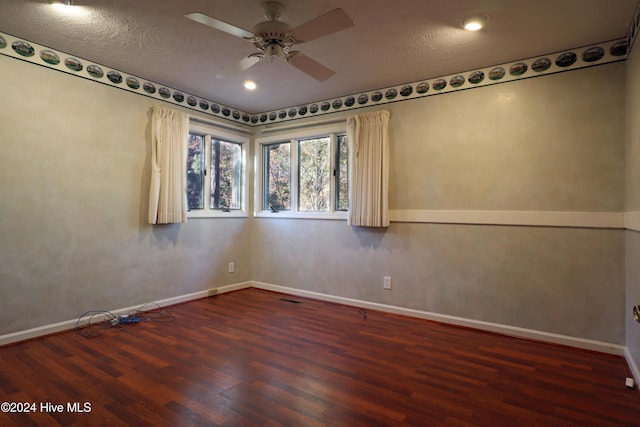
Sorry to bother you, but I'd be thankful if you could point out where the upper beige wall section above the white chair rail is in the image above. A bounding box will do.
[389,63,624,212]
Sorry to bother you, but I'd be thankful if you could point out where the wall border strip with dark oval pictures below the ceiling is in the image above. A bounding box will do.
[0,30,640,126]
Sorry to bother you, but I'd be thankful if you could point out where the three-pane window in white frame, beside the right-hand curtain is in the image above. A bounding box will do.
[256,123,349,218]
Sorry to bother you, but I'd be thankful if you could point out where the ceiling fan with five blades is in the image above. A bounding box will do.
[185,1,353,81]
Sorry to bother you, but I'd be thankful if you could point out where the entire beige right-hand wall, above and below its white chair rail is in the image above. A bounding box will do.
[252,63,625,344]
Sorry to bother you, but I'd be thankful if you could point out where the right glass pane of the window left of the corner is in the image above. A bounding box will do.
[210,139,242,210]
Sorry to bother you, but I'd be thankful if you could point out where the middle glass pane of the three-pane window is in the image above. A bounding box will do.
[298,137,331,211]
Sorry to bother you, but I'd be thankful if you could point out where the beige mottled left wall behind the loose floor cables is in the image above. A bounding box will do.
[0,56,251,334]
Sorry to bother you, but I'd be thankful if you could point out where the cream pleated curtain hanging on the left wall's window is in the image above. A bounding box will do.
[149,107,189,224]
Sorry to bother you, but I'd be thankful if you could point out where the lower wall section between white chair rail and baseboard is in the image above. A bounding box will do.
[253,219,624,344]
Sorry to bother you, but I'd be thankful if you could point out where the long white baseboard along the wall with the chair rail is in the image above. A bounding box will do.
[252,281,628,356]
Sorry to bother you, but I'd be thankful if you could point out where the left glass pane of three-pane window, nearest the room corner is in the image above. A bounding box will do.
[262,142,291,210]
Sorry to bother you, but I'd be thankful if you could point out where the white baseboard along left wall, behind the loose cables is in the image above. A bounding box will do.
[0,282,252,346]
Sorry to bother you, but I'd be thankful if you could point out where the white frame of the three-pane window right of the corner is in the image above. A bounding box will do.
[254,122,348,221]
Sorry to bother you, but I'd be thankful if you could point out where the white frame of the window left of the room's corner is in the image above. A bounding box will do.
[187,121,250,219]
